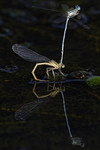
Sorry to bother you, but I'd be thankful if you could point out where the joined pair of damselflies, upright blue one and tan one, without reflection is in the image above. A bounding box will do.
[12,4,89,81]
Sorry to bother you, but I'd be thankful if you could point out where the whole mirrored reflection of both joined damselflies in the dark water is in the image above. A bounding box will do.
[15,82,85,148]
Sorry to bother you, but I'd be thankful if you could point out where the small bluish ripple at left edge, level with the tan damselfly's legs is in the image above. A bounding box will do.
[0,65,18,73]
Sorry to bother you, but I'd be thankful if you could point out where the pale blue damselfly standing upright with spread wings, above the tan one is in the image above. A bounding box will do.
[33,4,89,64]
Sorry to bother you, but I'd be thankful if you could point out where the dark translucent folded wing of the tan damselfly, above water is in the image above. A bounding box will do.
[12,44,50,62]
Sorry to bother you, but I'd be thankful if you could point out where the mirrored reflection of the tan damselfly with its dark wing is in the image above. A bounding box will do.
[15,82,65,120]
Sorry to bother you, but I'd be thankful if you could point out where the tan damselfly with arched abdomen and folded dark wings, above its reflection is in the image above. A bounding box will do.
[12,44,65,81]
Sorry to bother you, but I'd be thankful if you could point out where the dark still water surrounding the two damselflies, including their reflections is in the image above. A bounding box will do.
[0,0,100,150]
